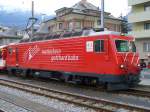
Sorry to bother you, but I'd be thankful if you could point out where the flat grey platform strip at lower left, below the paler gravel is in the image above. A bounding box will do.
[0,91,62,112]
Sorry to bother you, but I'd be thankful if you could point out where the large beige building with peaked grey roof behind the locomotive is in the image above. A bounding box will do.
[39,0,122,33]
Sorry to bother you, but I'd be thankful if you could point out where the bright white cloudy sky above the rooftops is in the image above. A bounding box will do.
[0,0,130,17]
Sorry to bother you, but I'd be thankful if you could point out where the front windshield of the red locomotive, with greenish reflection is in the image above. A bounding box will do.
[115,40,136,52]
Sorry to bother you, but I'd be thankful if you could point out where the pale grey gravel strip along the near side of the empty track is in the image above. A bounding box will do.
[0,85,95,112]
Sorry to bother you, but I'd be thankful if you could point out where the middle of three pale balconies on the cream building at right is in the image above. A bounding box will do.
[128,11,150,23]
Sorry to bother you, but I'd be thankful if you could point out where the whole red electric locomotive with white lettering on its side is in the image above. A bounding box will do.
[6,30,140,89]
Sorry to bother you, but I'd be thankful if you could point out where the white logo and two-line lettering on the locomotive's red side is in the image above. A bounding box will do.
[24,45,79,62]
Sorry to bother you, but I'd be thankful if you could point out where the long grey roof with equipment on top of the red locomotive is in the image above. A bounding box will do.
[20,29,131,43]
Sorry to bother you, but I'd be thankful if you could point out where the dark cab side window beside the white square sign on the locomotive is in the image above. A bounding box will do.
[94,40,104,52]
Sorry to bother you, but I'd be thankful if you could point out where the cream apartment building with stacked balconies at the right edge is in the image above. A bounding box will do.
[128,0,150,60]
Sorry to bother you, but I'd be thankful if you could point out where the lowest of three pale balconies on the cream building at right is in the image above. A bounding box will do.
[129,30,150,39]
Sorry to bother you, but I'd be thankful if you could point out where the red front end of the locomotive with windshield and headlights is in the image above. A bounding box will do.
[114,36,140,86]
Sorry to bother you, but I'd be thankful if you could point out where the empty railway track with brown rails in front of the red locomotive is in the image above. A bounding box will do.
[0,79,150,112]
